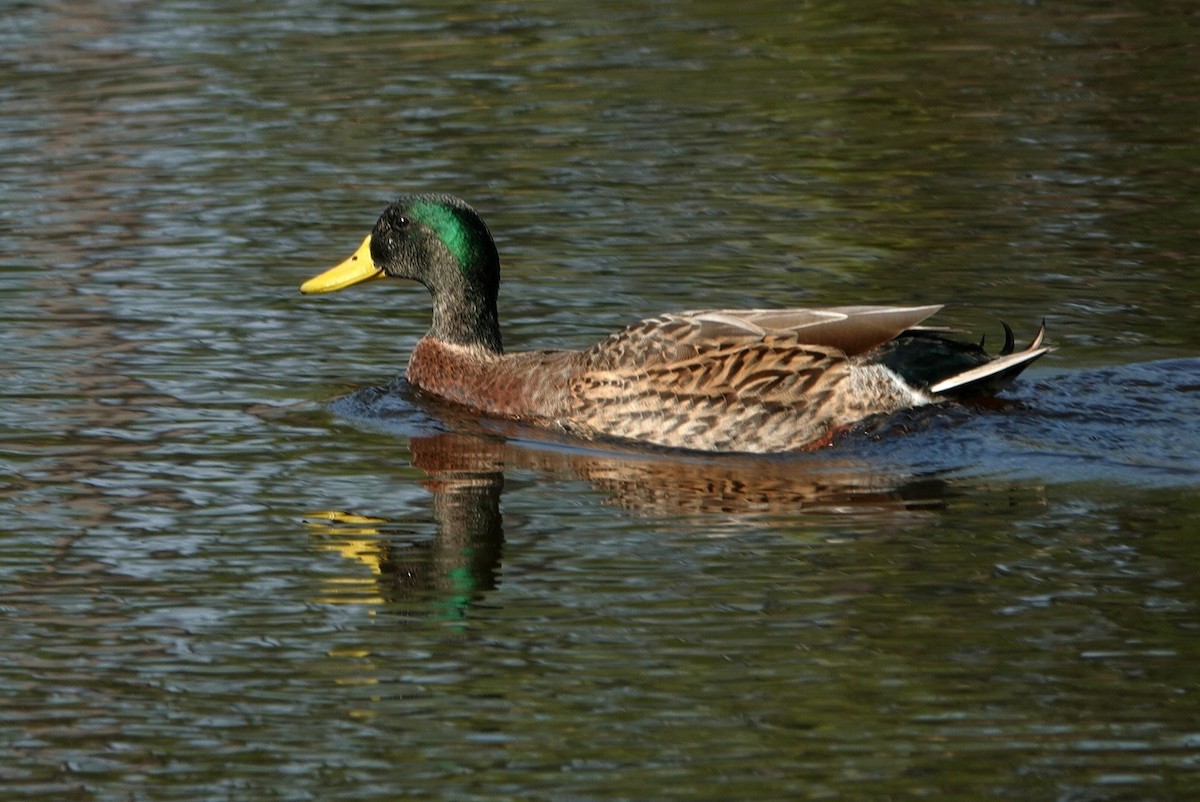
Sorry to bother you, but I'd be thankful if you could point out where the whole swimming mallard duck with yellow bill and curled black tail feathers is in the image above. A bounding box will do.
[300,194,1049,453]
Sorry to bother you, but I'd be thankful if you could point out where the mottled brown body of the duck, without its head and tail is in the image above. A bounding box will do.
[406,309,955,451]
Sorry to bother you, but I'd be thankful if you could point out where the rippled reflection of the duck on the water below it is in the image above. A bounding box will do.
[308,391,944,616]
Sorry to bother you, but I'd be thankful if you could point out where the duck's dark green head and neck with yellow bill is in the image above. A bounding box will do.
[300,194,502,352]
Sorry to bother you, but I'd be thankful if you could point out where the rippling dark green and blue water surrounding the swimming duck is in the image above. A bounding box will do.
[0,0,1200,801]
